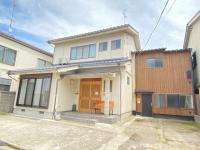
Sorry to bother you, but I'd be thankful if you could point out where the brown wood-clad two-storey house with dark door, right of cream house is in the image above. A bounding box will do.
[133,48,194,116]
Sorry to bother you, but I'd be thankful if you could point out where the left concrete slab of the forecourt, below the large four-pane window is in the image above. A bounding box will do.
[0,115,114,150]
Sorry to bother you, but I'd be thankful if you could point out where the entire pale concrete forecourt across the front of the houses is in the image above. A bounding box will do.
[0,115,200,150]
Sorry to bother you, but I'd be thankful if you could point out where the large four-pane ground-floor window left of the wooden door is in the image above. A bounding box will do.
[17,76,51,108]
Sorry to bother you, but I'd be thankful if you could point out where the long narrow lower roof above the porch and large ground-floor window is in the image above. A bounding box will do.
[8,57,131,75]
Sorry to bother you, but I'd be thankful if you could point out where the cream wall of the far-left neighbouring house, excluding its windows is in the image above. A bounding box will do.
[0,36,52,92]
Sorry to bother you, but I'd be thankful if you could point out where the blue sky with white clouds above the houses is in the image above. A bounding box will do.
[0,0,200,52]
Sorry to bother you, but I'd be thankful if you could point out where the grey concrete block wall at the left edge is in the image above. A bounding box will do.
[0,91,15,113]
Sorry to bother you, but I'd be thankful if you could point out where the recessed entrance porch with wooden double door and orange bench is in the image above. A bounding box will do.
[55,69,120,120]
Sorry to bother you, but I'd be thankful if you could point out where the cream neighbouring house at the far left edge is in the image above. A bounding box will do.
[0,32,52,92]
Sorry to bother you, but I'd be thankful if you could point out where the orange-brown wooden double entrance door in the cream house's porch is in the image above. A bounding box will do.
[79,78,102,112]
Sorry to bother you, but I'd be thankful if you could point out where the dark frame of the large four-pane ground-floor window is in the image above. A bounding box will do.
[16,74,52,109]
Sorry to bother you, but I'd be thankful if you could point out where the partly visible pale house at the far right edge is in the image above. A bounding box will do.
[183,11,200,94]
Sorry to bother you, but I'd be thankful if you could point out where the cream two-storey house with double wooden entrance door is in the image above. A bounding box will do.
[9,25,140,118]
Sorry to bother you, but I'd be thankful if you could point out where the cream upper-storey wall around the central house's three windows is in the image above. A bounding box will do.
[53,32,136,64]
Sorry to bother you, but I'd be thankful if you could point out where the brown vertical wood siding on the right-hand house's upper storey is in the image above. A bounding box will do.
[135,51,193,94]
